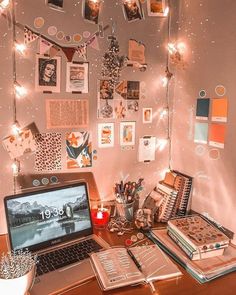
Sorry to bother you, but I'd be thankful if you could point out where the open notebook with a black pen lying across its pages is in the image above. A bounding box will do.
[90,245,182,291]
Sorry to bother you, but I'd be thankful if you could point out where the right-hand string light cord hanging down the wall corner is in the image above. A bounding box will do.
[166,1,172,170]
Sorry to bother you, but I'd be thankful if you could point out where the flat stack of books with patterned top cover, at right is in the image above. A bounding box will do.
[167,215,230,260]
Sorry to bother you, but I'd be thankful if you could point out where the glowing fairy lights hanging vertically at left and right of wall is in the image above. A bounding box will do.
[0,0,185,185]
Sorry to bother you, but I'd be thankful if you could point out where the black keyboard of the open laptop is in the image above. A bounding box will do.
[36,239,102,276]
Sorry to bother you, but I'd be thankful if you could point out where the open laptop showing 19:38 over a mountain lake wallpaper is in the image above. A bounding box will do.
[4,182,109,295]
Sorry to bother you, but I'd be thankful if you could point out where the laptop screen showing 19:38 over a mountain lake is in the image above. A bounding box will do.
[4,183,92,250]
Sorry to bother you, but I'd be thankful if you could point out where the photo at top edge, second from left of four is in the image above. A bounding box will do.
[82,0,102,24]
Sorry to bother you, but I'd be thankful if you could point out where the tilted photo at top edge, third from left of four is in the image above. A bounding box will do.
[123,0,143,22]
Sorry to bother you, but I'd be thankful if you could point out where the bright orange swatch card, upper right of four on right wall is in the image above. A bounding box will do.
[211,98,228,122]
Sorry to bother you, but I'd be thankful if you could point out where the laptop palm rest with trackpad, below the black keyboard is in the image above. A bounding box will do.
[30,259,95,295]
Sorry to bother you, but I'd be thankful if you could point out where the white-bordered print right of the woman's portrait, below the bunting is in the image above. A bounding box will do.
[66,62,88,93]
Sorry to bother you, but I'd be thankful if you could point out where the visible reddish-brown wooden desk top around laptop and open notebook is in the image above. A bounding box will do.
[0,230,236,295]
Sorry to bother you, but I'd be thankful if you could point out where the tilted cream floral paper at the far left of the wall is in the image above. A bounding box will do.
[2,123,38,159]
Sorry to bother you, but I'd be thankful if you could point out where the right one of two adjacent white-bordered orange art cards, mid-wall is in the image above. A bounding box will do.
[120,122,135,146]
